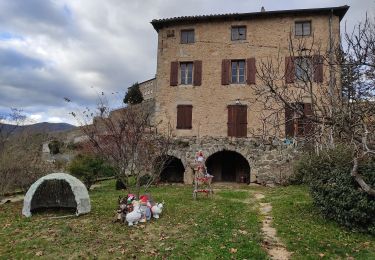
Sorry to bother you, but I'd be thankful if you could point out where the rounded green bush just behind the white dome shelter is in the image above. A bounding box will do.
[68,154,114,189]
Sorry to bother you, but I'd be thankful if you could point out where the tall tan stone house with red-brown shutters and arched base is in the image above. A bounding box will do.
[145,6,349,183]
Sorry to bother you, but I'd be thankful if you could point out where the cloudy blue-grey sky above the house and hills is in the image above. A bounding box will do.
[0,0,375,124]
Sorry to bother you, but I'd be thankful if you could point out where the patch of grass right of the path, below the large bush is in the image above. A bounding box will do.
[264,186,375,259]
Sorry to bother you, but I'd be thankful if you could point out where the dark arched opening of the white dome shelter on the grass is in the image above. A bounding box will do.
[30,180,77,213]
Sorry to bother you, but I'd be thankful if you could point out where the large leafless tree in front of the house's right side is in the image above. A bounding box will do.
[253,18,375,196]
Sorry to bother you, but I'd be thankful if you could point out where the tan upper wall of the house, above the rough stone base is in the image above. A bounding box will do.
[155,11,340,137]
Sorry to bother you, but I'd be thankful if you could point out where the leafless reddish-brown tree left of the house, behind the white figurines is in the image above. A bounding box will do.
[72,95,171,195]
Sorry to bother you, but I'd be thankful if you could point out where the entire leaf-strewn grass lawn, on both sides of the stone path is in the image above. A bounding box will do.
[0,181,375,259]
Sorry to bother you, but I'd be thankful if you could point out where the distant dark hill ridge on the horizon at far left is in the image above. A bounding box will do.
[0,122,76,134]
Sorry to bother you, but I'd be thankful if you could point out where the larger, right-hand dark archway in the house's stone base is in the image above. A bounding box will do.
[206,151,250,183]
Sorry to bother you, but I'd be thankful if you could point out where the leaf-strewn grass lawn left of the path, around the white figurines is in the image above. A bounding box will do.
[0,181,267,259]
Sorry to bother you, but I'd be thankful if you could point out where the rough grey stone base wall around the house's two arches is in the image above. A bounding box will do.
[170,137,299,185]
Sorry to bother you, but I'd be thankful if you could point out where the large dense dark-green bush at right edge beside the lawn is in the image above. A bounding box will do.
[295,146,375,234]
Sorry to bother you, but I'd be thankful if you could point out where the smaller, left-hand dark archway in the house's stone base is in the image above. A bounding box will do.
[160,156,185,183]
